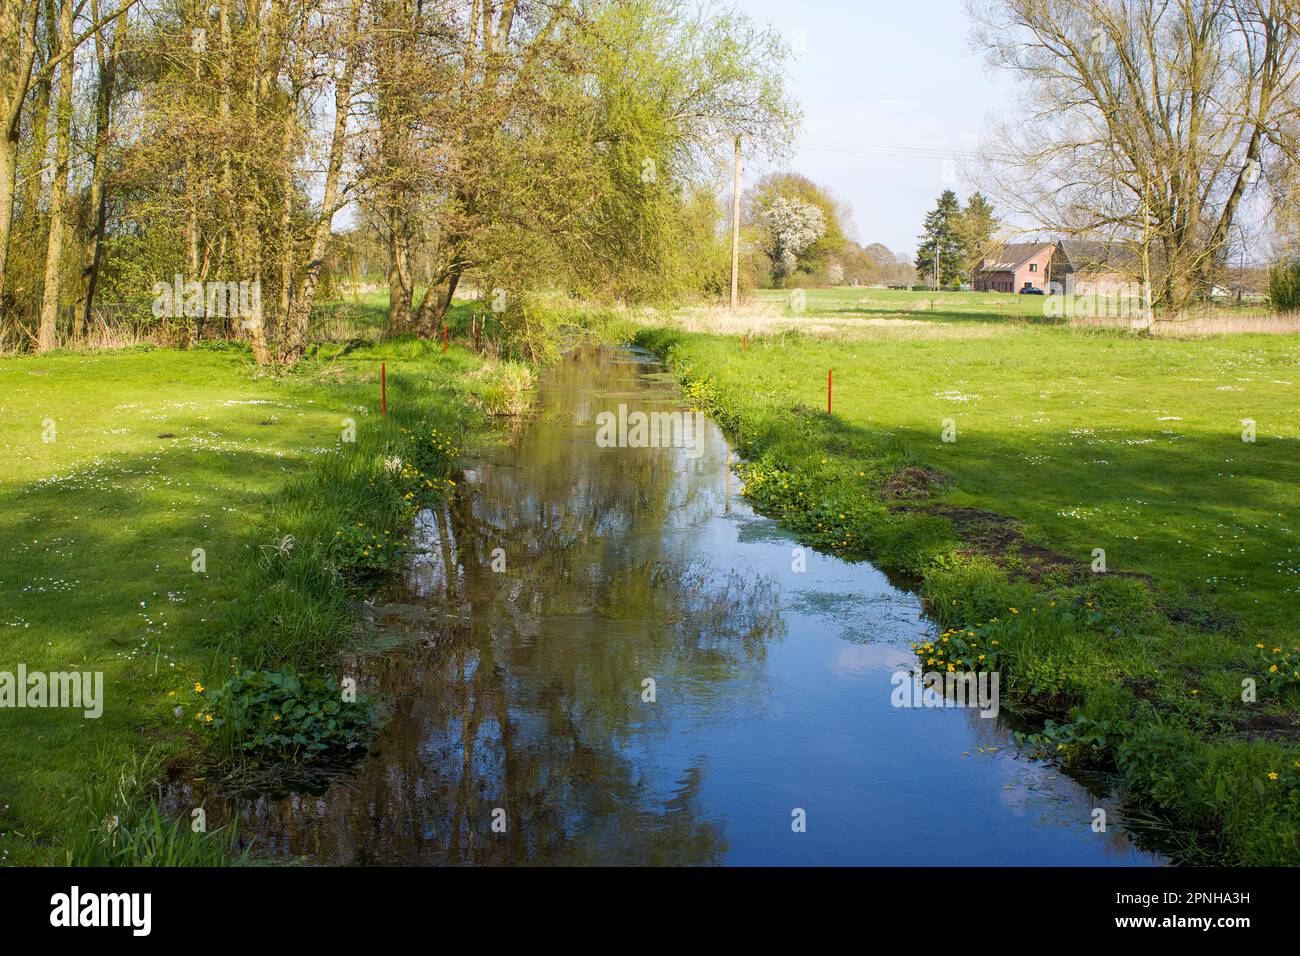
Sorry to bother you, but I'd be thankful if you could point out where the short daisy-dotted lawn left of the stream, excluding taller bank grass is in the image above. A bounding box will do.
[0,332,491,864]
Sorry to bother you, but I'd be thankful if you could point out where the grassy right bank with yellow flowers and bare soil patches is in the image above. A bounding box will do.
[640,293,1300,864]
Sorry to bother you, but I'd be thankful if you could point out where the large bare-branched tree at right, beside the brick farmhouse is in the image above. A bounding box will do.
[970,0,1300,308]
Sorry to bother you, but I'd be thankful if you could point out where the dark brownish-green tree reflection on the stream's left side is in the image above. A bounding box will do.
[217,349,784,864]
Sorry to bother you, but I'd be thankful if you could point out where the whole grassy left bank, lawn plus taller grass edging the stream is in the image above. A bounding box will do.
[0,339,527,864]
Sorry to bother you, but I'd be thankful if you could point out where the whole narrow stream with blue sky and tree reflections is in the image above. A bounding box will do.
[189,349,1164,865]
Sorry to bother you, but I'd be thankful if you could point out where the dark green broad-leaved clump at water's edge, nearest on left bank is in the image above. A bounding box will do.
[195,667,373,762]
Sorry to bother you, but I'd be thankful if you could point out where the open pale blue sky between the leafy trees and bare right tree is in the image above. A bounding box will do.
[735,0,1017,256]
